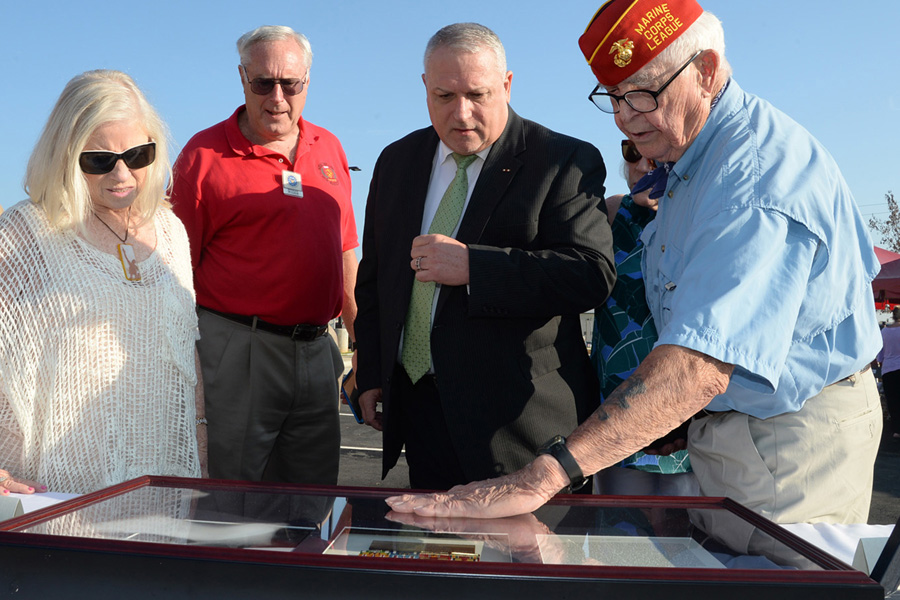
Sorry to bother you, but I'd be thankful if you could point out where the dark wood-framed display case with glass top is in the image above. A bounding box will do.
[0,477,884,600]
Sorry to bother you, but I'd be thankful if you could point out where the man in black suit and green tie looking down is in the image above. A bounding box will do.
[356,23,615,489]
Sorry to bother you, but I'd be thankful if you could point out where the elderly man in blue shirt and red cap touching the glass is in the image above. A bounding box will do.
[388,0,882,523]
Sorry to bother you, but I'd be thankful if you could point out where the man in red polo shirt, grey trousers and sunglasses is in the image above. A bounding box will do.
[172,26,358,484]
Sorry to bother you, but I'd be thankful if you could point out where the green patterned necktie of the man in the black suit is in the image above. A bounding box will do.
[400,152,478,383]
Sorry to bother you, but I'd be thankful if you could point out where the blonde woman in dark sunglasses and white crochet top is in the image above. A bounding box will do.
[0,71,205,494]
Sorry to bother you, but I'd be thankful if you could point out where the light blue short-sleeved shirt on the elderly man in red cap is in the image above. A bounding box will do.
[641,80,881,418]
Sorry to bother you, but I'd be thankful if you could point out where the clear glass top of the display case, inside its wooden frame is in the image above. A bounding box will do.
[12,480,822,570]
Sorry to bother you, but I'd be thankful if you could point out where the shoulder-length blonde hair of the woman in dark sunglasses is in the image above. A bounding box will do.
[25,70,172,234]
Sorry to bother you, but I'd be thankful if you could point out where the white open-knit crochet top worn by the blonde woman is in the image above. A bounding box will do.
[0,200,200,493]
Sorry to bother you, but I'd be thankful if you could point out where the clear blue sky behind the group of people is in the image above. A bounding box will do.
[0,0,900,247]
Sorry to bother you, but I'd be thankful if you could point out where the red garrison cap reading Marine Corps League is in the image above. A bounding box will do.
[578,0,703,86]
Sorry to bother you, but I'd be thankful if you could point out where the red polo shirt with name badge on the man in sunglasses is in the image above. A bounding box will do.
[171,106,359,325]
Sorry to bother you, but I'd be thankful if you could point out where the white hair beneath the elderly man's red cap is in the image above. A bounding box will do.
[623,11,731,87]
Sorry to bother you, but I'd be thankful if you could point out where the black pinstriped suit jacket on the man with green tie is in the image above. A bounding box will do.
[355,109,615,480]
